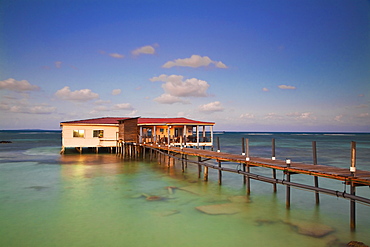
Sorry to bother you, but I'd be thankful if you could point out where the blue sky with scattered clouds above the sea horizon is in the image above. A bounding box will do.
[0,0,370,132]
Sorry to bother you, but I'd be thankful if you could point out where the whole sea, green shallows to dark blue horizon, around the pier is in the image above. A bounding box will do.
[0,131,370,247]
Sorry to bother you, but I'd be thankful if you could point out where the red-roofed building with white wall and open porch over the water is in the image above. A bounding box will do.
[60,117,215,152]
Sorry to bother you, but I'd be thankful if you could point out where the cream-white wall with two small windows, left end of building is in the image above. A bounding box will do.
[62,125,118,147]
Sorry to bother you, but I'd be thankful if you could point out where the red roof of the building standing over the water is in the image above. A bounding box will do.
[61,117,215,125]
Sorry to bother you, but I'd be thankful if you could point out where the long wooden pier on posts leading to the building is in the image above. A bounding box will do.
[118,139,370,230]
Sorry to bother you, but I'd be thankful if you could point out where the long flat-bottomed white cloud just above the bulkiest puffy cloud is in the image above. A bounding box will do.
[162,55,228,69]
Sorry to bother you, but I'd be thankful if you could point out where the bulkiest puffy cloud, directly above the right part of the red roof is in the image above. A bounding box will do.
[150,74,209,97]
